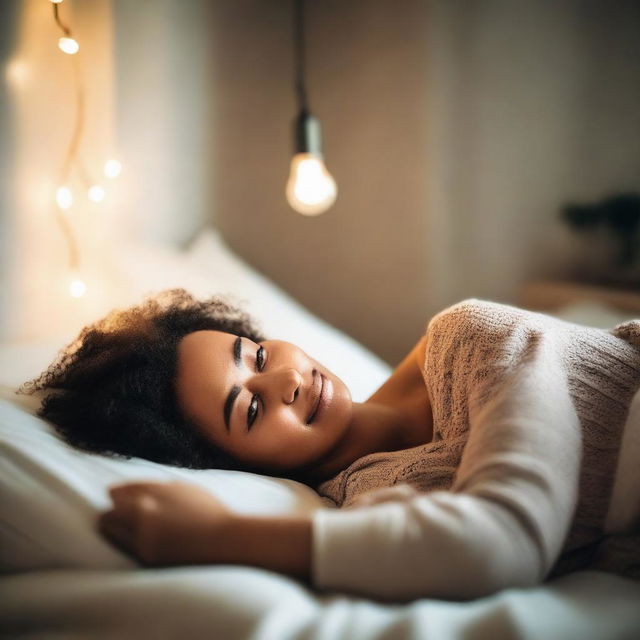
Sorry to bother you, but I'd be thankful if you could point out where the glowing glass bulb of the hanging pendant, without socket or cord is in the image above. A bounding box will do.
[286,153,338,216]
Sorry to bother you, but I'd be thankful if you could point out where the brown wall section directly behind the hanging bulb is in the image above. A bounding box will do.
[211,0,428,362]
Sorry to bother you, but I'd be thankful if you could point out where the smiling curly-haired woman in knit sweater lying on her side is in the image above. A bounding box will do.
[23,289,640,600]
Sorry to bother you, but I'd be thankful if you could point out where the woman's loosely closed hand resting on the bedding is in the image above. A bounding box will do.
[98,482,237,566]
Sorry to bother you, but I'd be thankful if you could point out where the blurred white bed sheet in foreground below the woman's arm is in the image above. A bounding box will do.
[0,566,640,640]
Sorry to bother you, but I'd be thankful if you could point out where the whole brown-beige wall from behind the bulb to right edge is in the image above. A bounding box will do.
[206,0,640,362]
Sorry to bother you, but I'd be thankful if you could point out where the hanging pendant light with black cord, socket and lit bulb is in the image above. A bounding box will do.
[286,0,337,216]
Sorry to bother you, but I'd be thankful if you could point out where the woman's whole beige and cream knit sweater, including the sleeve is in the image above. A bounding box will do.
[312,299,640,600]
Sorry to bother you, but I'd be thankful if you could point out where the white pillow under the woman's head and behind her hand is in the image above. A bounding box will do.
[0,386,335,572]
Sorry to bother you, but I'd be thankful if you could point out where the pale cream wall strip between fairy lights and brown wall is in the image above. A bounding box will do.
[111,0,217,246]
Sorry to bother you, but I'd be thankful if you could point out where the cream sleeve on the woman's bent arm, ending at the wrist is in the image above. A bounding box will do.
[312,332,581,601]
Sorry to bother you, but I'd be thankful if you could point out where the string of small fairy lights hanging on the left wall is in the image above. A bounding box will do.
[50,0,122,298]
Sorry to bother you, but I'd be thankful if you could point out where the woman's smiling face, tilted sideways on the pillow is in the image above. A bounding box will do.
[176,331,352,471]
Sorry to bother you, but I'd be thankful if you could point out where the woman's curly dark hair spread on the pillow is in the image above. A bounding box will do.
[18,289,264,473]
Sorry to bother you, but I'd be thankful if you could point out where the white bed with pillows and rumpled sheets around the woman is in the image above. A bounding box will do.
[0,229,640,640]
